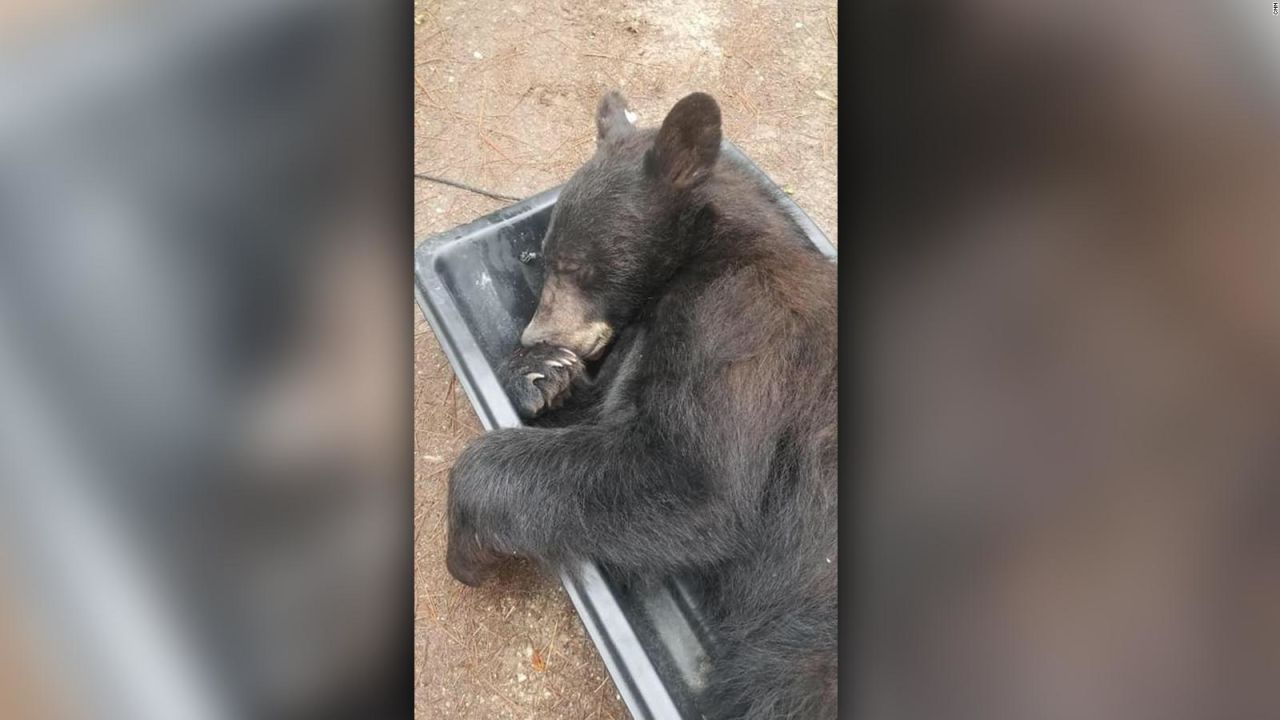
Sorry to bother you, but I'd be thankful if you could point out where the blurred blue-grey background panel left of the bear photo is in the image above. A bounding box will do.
[0,0,412,720]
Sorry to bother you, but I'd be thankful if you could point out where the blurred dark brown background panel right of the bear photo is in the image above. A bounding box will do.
[842,0,1280,720]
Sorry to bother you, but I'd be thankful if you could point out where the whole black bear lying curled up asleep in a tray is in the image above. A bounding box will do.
[447,92,837,719]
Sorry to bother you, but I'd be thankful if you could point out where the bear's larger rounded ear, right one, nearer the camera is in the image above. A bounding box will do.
[653,92,721,190]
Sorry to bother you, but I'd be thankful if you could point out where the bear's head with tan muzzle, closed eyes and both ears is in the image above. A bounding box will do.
[521,91,721,359]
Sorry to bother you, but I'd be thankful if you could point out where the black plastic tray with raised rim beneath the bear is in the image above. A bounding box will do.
[413,141,836,720]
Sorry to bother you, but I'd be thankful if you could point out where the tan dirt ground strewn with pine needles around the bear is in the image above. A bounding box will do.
[413,0,837,720]
